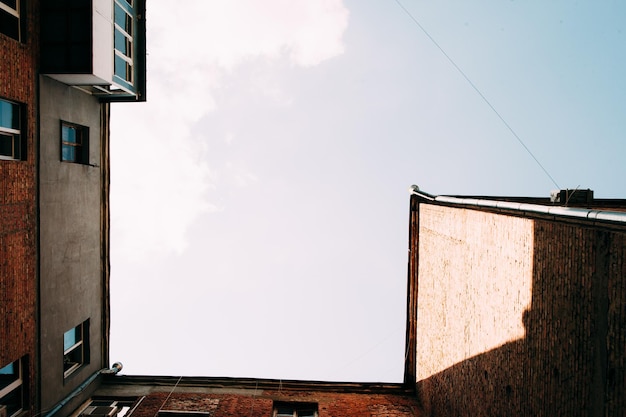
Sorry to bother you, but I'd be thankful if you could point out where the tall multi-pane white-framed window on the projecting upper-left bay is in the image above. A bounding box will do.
[113,0,135,84]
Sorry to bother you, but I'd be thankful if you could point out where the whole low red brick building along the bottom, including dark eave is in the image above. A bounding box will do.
[72,376,420,417]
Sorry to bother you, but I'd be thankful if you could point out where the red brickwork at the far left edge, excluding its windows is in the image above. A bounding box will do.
[0,0,39,412]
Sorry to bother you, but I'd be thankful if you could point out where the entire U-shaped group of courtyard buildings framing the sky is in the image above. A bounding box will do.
[0,0,626,417]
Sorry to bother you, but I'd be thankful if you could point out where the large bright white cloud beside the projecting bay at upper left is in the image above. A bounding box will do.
[111,0,348,261]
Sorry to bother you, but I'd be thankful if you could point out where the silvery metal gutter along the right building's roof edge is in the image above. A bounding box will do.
[409,185,626,224]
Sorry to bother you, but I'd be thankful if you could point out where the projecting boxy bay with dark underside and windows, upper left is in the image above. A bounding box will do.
[41,0,146,102]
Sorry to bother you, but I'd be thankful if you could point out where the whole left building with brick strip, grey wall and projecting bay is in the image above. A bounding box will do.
[0,0,145,417]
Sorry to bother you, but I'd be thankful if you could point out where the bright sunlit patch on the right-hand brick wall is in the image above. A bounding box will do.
[416,205,533,379]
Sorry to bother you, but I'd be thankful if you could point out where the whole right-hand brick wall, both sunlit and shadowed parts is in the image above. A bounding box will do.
[412,202,626,416]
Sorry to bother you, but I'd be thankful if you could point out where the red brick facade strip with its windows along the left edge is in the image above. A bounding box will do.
[0,0,39,413]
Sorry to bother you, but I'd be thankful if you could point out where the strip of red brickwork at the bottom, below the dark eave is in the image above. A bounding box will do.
[126,388,421,417]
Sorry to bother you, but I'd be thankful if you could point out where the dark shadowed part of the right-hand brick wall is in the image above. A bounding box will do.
[417,221,626,417]
